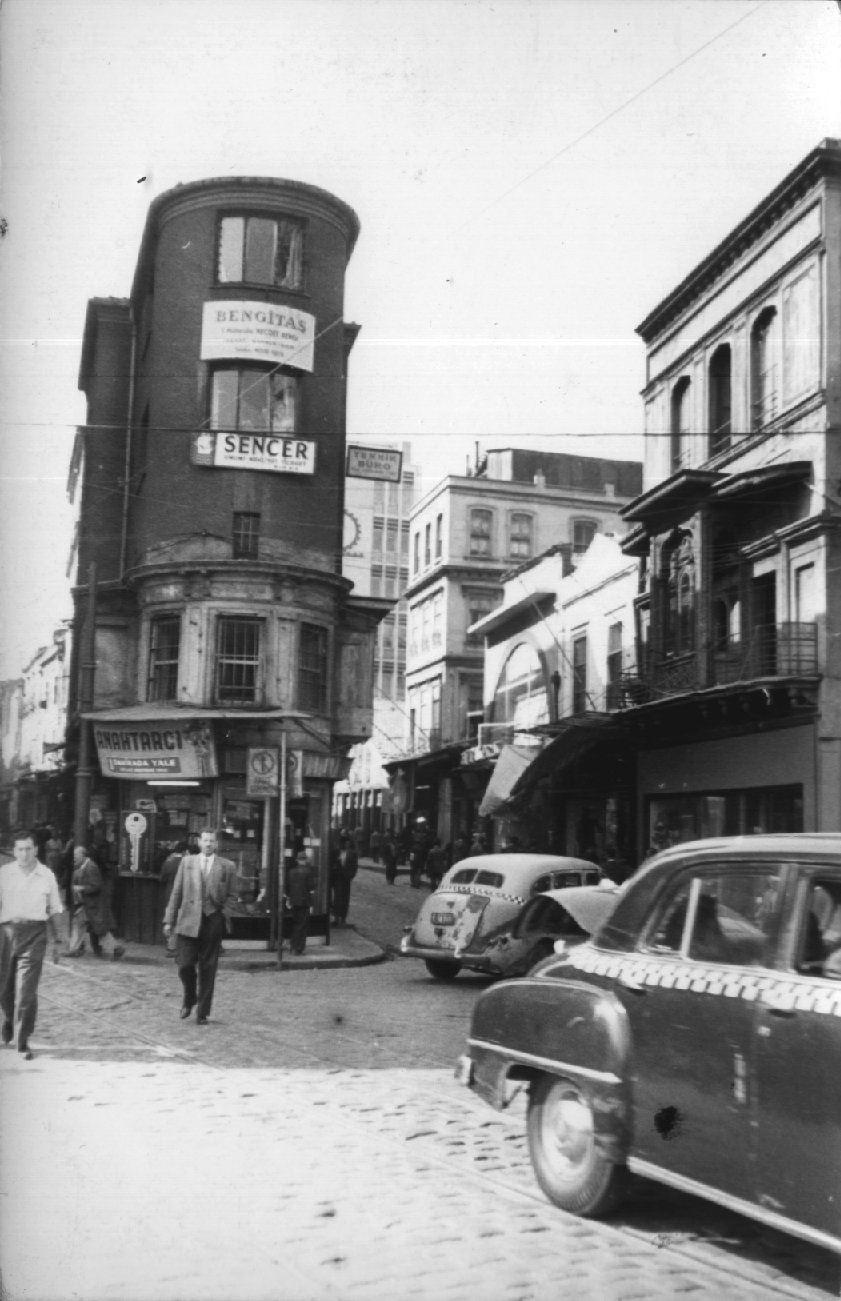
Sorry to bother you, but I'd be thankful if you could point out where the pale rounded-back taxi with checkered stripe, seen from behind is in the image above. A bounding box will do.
[400,853,601,980]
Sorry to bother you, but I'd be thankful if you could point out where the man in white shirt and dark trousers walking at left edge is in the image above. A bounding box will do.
[0,831,64,1060]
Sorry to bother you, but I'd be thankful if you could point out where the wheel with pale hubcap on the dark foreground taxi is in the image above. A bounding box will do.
[529,1075,626,1215]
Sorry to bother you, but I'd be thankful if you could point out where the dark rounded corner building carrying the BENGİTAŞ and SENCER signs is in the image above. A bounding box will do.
[70,177,389,941]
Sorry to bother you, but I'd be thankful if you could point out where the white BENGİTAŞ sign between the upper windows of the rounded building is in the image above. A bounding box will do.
[202,299,315,371]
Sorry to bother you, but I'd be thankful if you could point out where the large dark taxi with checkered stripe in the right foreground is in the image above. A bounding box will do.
[457,834,841,1252]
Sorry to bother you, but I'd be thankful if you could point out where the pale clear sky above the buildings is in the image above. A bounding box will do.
[0,0,841,679]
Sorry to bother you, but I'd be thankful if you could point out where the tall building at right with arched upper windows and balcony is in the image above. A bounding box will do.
[611,141,841,855]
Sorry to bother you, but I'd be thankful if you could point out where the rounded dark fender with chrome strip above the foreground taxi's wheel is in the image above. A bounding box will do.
[469,977,630,1133]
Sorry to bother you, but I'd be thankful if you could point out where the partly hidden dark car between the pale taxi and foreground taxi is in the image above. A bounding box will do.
[484,877,621,977]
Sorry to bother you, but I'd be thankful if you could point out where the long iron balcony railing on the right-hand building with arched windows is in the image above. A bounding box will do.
[617,622,819,709]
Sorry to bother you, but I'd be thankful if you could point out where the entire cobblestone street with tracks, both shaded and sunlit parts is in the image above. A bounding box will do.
[0,873,836,1301]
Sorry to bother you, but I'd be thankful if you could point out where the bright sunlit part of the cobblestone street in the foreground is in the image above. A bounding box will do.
[0,1054,819,1301]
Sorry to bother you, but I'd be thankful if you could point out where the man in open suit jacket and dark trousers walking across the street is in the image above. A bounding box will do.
[164,831,237,1025]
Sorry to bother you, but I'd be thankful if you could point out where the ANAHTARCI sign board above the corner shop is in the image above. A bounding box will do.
[94,719,217,782]
